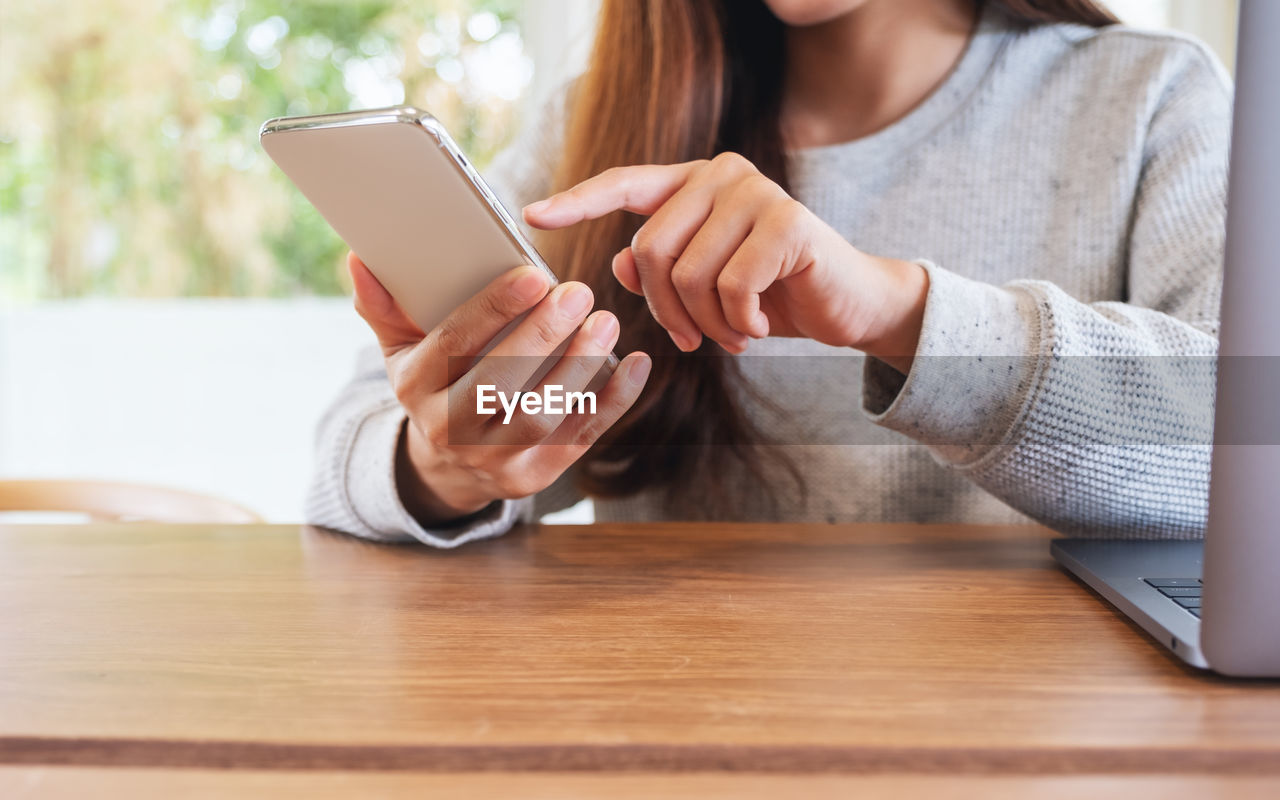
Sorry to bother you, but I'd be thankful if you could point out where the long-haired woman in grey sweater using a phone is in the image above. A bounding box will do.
[308,0,1230,547]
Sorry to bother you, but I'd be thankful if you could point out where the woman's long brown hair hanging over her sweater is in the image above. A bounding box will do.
[539,0,1117,508]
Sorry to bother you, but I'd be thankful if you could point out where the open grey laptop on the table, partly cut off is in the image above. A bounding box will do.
[1052,0,1280,677]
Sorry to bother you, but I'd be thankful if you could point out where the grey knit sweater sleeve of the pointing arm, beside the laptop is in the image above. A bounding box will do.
[863,42,1230,538]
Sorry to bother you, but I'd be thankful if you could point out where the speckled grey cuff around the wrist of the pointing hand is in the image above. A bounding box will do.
[863,261,1042,466]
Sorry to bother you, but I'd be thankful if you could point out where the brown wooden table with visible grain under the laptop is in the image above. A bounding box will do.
[0,524,1280,799]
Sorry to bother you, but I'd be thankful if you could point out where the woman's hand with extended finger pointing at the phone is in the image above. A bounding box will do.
[525,154,928,372]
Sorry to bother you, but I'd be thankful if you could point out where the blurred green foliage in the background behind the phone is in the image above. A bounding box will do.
[0,0,531,300]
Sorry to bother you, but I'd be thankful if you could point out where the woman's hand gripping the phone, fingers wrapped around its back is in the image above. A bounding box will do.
[347,253,650,525]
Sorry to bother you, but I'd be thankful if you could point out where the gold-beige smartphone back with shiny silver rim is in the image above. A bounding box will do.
[261,108,549,332]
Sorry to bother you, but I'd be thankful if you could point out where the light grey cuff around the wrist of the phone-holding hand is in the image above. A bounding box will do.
[346,404,525,548]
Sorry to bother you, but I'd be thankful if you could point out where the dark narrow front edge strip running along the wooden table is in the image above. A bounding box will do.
[0,736,1280,774]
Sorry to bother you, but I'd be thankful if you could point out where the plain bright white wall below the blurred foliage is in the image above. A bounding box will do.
[0,298,372,521]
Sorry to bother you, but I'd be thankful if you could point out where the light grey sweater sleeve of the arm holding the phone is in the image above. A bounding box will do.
[305,91,580,548]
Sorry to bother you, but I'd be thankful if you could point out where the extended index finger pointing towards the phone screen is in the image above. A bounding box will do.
[525,161,700,230]
